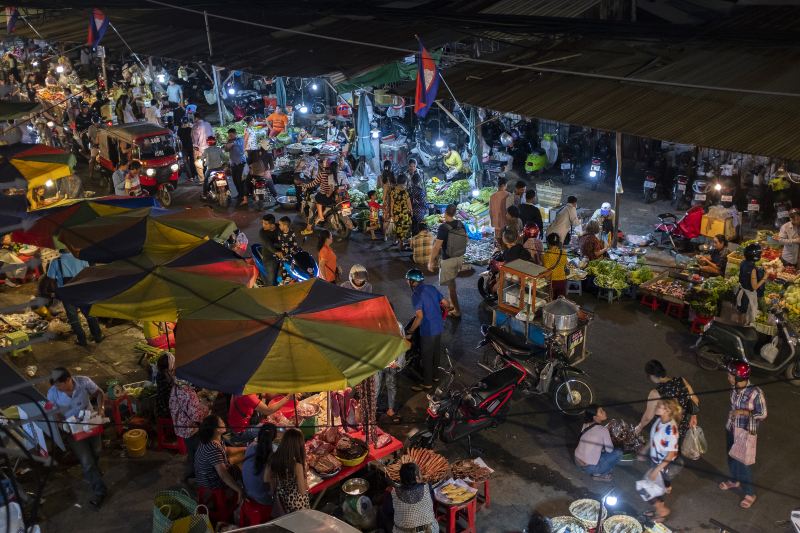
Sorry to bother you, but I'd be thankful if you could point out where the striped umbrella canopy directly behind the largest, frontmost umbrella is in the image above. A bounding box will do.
[58,241,255,322]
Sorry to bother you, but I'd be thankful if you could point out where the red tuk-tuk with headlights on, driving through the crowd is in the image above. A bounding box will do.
[96,122,181,207]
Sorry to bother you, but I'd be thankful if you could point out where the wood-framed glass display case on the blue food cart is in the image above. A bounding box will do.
[497,259,550,320]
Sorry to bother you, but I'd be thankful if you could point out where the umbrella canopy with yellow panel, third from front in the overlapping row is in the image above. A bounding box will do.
[58,208,236,263]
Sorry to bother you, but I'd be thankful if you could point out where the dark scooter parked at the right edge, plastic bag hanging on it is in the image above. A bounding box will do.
[694,311,800,386]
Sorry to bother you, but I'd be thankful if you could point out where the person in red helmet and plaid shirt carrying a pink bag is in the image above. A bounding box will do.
[719,361,767,509]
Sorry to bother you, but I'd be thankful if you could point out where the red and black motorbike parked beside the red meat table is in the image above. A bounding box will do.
[407,350,526,455]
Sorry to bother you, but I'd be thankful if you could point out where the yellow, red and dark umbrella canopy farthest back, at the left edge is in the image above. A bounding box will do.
[0,143,75,189]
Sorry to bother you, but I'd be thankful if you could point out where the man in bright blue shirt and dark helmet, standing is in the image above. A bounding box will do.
[406,268,450,392]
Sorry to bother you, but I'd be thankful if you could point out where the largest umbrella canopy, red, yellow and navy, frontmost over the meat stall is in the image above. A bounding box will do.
[175,279,408,394]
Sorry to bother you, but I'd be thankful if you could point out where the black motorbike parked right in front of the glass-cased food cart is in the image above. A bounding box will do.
[478,325,594,415]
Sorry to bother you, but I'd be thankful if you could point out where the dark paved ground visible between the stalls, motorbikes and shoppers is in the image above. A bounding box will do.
[0,172,800,533]
